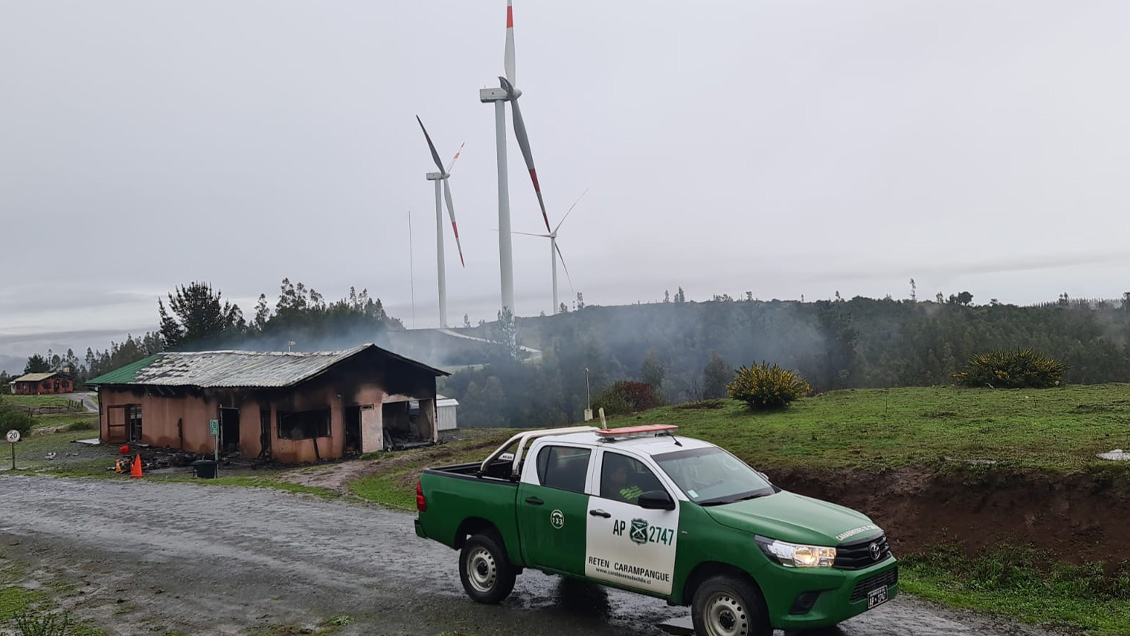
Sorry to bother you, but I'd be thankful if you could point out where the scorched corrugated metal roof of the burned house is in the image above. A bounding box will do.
[87,345,447,389]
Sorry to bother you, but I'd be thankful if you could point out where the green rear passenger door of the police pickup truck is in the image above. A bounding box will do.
[518,445,592,575]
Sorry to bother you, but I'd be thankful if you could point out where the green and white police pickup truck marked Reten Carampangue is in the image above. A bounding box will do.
[416,425,898,636]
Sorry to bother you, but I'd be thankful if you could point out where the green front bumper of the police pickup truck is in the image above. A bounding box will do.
[763,557,898,629]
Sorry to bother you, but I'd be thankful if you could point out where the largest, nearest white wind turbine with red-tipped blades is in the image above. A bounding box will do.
[479,0,556,312]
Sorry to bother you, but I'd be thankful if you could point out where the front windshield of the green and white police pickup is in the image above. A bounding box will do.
[652,446,776,506]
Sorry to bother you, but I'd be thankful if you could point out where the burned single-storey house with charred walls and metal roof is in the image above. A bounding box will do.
[89,345,447,463]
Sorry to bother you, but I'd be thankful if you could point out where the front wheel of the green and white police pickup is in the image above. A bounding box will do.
[690,575,773,636]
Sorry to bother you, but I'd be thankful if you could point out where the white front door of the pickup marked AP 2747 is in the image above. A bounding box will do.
[584,451,679,595]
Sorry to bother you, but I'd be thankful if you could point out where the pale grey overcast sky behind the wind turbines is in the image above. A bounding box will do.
[0,0,1130,366]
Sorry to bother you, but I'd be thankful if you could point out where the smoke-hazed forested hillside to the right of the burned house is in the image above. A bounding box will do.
[442,289,1130,426]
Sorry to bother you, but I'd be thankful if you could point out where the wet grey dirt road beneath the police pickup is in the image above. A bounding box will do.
[0,476,1048,636]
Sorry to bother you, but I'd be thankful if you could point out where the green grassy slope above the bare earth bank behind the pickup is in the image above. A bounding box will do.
[628,384,1130,470]
